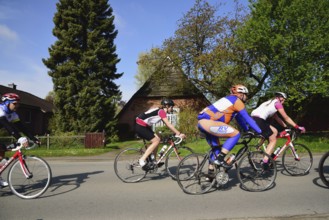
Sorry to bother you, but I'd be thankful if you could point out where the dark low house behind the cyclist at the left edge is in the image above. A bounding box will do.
[0,84,54,135]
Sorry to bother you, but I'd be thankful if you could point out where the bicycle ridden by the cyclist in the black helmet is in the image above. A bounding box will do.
[114,135,193,183]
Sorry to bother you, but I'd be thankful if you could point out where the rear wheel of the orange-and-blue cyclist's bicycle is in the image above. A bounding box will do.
[176,153,217,195]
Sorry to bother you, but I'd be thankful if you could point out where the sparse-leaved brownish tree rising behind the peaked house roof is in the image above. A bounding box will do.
[164,0,250,97]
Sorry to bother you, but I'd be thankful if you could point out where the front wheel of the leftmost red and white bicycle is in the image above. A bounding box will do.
[8,156,52,199]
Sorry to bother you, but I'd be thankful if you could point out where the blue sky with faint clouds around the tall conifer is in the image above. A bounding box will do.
[0,0,247,101]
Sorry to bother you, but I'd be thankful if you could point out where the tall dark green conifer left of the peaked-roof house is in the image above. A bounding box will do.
[43,0,122,138]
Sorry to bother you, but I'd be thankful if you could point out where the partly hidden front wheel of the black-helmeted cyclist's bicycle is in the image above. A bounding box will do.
[165,146,194,180]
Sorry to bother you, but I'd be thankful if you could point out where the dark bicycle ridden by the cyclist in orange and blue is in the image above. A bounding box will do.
[176,132,277,195]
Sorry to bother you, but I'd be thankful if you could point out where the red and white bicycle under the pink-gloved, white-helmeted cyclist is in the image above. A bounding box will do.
[262,129,313,176]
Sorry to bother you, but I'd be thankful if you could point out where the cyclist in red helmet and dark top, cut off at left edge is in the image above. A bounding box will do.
[0,93,40,187]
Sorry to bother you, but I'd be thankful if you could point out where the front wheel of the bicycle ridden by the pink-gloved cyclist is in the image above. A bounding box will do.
[282,143,313,176]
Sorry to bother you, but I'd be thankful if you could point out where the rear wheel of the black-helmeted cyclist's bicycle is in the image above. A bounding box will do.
[114,148,147,183]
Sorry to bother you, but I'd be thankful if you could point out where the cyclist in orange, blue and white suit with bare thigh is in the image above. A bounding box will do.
[198,85,262,170]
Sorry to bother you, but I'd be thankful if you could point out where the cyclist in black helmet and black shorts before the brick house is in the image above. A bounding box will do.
[135,98,186,171]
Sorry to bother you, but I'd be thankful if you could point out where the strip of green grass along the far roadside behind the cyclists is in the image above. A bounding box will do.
[6,135,329,157]
